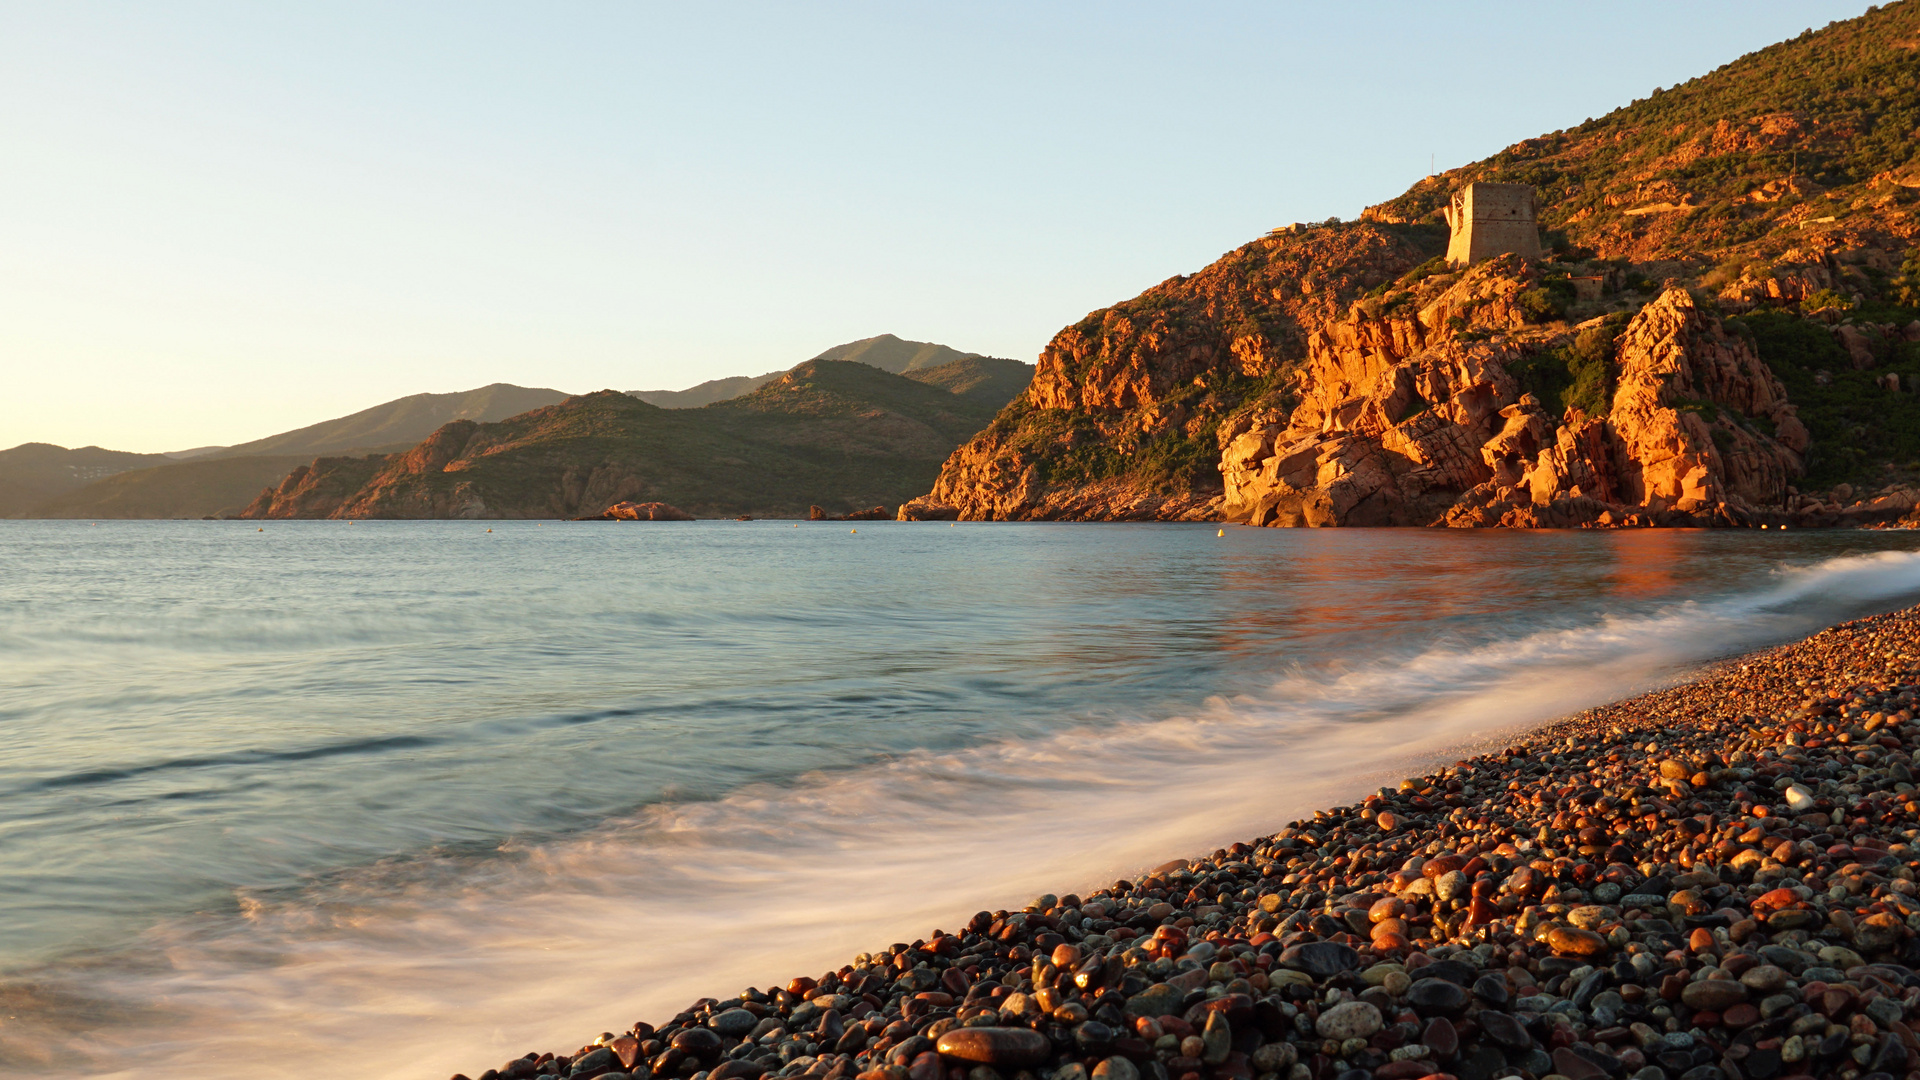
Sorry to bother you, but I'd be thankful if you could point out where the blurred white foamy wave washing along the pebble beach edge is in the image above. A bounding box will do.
[11,553,1920,1078]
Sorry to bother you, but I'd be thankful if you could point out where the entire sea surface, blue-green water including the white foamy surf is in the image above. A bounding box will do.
[0,521,1920,1076]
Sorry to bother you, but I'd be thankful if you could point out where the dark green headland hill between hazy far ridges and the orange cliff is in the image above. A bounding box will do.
[246,356,1025,517]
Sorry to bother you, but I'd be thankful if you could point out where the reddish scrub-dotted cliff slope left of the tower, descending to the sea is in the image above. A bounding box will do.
[906,225,1446,521]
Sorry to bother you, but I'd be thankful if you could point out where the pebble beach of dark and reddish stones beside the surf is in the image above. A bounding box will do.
[455,607,1920,1080]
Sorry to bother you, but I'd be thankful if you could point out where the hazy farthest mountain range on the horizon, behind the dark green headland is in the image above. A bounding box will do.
[0,334,1033,517]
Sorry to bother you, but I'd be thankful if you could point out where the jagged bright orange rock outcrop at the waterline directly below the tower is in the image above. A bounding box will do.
[1221,272,1807,528]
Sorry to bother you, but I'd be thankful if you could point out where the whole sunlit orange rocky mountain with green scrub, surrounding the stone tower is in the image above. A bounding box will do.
[912,2,1920,525]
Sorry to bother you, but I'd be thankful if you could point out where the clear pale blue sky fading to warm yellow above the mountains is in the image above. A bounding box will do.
[0,0,1866,452]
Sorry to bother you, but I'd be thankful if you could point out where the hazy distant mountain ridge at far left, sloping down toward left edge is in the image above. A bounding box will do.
[16,382,566,517]
